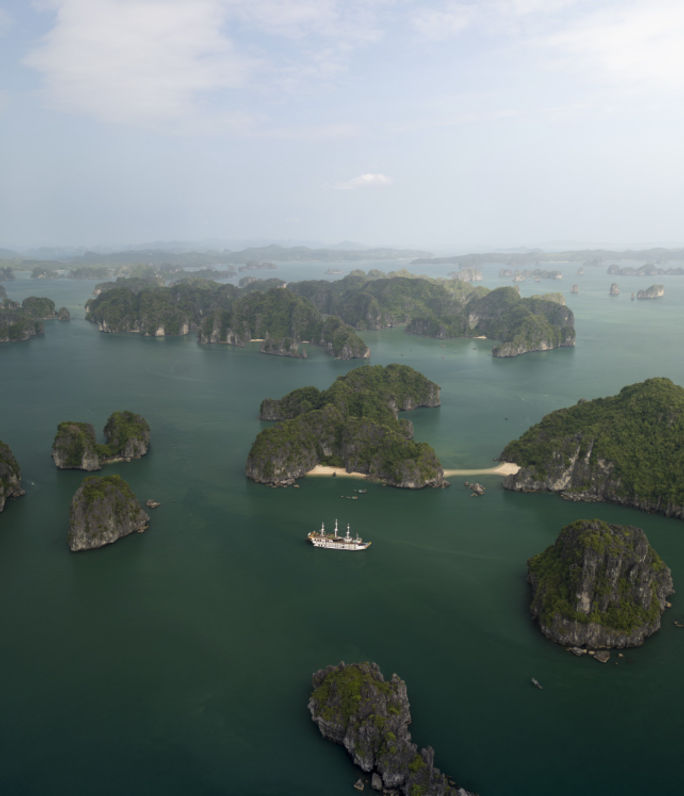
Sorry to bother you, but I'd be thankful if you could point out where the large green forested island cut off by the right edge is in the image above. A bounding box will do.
[500,378,684,519]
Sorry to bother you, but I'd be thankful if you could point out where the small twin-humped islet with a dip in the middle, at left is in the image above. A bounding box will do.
[52,411,150,471]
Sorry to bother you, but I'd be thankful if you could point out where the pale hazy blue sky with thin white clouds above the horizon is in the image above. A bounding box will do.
[0,0,684,249]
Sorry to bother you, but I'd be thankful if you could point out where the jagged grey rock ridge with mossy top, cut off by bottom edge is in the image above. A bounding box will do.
[308,662,476,796]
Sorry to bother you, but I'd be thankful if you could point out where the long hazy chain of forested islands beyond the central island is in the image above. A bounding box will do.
[86,271,575,359]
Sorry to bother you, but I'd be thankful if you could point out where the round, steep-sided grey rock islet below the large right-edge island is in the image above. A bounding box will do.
[528,520,674,649]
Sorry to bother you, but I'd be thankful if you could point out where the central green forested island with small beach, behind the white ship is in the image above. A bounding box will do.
[245,364,447,489]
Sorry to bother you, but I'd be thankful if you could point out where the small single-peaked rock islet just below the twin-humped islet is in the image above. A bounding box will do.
[67,475,150,552]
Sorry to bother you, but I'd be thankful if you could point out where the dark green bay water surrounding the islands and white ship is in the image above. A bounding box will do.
[0,269,684,796]
